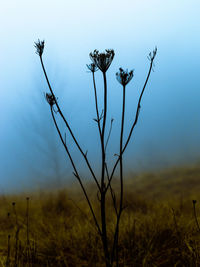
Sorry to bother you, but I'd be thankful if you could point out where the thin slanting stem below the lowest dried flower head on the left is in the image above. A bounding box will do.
[51,107,102,236]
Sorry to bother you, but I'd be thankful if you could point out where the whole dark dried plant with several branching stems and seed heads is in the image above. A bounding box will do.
[35,40,157,267]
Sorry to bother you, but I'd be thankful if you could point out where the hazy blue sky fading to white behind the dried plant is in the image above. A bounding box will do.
[0,0,200,191]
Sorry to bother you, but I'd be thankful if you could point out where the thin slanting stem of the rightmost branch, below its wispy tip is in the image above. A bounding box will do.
[106,58,154,191]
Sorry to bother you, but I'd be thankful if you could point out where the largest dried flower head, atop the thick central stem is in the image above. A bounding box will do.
[90,49,115,72]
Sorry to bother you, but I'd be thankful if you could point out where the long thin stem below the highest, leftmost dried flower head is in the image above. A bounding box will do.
[40,56,100,190]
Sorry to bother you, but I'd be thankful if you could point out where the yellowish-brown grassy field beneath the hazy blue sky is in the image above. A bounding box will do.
[0,166,200,267]
